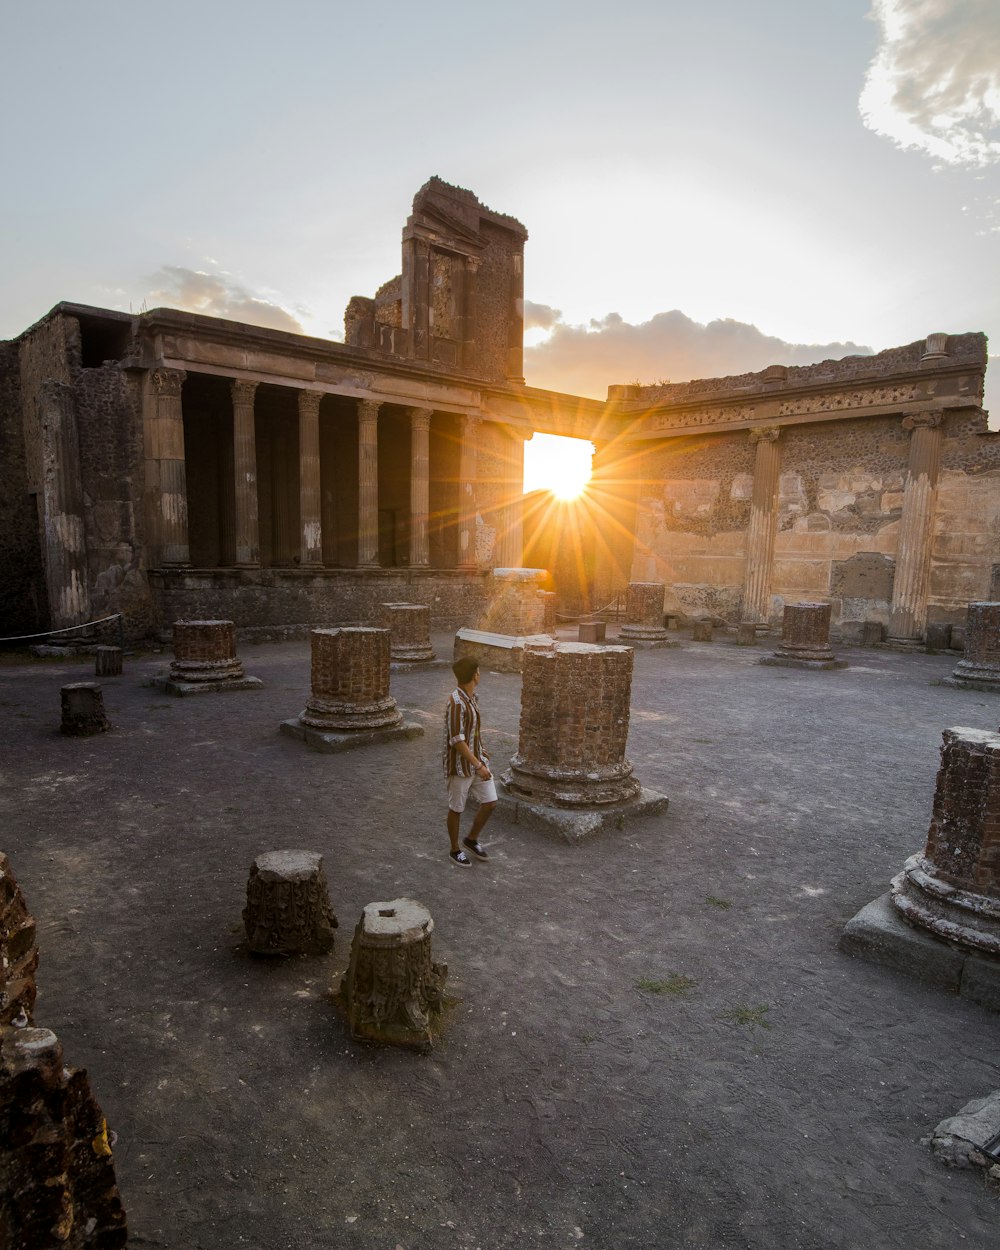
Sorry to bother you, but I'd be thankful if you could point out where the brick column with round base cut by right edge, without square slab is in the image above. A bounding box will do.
[893,729,1000,956]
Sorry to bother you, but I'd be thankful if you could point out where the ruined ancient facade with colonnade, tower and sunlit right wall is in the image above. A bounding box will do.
[0,179,1000,641]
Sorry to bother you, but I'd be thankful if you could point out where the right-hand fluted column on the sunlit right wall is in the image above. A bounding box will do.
[889,413,943,641]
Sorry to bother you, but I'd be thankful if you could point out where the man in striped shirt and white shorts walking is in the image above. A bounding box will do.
[444,655,496,868]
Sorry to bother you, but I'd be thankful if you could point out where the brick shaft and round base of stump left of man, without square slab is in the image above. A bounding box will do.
[299,626,403,730]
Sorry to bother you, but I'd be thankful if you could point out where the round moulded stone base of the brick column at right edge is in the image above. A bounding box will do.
[890,855,1000,955]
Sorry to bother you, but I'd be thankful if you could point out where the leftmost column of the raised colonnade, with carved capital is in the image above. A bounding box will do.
[143,369,191,568]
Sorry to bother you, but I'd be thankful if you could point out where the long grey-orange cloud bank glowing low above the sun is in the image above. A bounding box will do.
[524,305,871,399]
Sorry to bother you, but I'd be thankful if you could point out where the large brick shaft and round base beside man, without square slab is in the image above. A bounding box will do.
[504,643,640,808]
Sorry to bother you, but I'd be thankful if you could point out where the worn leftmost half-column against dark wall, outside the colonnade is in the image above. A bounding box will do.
[39,379,90,629]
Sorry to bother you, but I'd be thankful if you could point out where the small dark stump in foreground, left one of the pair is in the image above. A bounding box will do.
[243,851,338,955]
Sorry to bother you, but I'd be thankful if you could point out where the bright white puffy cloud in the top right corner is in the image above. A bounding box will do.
[859,0,1000,169]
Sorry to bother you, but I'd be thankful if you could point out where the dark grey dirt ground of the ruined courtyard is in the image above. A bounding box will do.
[0,635,1000,1250]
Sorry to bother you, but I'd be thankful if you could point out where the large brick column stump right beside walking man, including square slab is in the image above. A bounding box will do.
[500,643,668,843]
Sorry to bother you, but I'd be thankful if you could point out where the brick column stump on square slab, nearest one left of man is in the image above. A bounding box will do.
[279,625,424,751]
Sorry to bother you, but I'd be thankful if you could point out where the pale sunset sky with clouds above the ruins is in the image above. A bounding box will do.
[0,0,1000,425]
